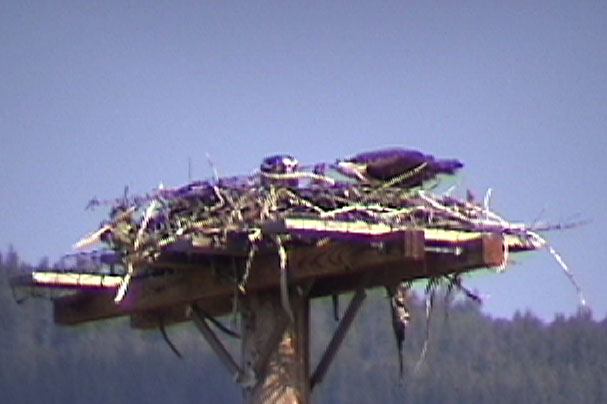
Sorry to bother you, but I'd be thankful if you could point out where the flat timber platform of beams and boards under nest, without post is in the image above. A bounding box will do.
[18,227,532,328]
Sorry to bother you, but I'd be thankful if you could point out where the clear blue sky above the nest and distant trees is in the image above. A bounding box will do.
[0,0,607,319]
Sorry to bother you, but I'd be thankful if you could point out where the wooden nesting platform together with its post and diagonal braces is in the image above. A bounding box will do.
[12,223,540,404]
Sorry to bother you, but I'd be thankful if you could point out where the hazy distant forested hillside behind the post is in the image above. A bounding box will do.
[0,251,607,404]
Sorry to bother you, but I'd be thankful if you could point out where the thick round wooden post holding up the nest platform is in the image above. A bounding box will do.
[241,291,310,404]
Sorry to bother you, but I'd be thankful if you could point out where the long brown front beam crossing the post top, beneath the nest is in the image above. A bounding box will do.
[54,234,418,325]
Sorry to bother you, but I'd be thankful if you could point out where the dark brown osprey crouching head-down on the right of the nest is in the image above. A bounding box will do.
[334,148,464,188]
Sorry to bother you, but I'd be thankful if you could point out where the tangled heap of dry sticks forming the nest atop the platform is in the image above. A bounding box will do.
[71,172,543,274]
